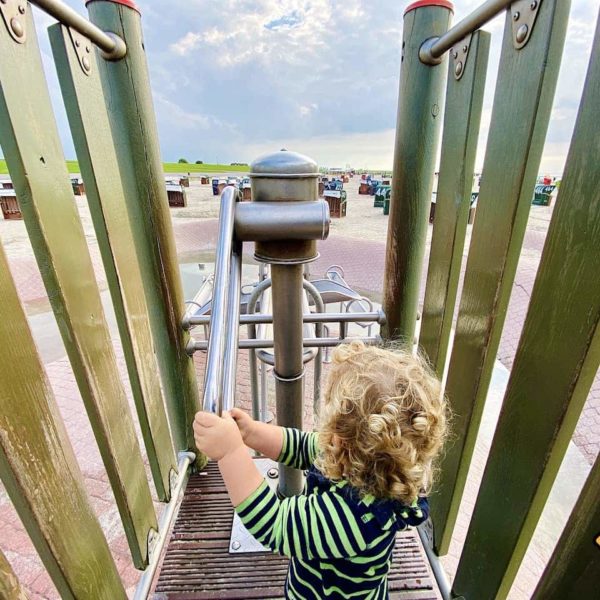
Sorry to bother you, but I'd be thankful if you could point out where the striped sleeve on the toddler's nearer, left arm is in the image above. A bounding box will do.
[235,481,367,560]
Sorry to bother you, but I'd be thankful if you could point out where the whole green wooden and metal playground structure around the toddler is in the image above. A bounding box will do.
[0,0,600,600]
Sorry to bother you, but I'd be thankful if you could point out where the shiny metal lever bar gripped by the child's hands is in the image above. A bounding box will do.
[202,187,239,414]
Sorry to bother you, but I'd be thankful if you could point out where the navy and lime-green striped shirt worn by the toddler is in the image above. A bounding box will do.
[236,429,429,600]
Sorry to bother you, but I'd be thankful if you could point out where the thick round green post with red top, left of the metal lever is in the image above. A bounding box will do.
[88,0,200,452]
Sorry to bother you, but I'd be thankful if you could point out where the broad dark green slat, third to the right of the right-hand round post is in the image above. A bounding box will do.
[454,11,600,599]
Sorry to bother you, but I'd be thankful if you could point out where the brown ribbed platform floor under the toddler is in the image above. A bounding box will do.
[154,463,440,600]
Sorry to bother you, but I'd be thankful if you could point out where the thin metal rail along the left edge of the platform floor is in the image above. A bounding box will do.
[133,452,196,600]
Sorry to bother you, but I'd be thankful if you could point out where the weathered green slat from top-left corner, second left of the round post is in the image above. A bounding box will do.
[0,9,157,567]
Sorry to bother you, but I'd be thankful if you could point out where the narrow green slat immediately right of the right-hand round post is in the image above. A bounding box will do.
[419,31,490,377]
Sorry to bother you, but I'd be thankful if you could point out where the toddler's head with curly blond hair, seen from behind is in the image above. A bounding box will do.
[317,342,447,503]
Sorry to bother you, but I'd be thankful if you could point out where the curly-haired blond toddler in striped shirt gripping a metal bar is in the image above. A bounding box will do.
[194,342,447,600]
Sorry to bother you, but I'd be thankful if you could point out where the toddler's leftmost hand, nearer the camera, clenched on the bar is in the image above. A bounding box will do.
[194,412,244,460]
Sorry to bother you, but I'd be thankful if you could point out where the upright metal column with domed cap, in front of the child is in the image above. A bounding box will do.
[250,150,328,496]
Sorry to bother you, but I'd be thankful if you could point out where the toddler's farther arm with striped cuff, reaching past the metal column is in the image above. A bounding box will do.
[231,408,318,469]
